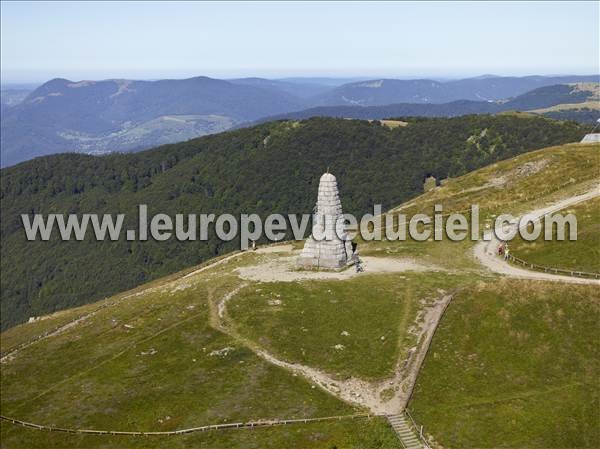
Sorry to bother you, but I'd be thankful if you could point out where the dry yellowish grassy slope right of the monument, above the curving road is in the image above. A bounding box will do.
[359,144,600,272]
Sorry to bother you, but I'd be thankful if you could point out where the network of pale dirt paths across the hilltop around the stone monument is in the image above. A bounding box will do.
[7,186,600,414]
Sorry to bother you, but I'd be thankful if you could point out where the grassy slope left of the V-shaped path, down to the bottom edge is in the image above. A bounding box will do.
[2,256,397,449]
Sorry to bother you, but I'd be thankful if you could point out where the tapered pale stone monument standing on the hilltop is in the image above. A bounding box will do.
[298,172,352,269]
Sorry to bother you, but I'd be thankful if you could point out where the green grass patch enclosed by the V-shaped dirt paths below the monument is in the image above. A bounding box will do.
[228,273,466,379]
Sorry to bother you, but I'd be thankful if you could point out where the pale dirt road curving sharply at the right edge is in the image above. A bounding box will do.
[473,186,600,285]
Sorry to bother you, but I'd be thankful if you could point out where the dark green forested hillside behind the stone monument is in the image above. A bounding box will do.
[1,116,587,329]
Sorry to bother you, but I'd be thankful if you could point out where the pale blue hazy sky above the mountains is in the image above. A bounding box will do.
[1,1,600,82]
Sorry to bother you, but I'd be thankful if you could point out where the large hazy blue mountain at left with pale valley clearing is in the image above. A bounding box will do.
[1,77,304,166]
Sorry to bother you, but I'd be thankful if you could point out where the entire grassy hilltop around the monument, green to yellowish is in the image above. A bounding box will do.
[1,141,600,449]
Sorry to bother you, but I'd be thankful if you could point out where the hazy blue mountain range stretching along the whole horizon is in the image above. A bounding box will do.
[0,75,598,166]
